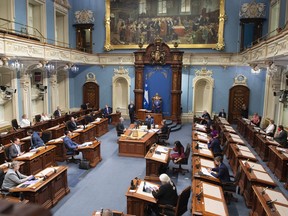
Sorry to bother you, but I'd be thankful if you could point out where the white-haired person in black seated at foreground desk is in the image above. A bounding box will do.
[152,173,178,215]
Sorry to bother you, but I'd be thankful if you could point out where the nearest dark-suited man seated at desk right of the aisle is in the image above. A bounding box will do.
[208,156,230,183]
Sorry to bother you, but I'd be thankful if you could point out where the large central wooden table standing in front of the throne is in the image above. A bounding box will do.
[118,129,157,157]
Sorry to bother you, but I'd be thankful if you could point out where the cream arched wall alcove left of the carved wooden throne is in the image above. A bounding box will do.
[112,67,131,115]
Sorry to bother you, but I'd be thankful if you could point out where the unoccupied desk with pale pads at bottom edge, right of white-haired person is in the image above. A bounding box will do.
[192,179,229,216]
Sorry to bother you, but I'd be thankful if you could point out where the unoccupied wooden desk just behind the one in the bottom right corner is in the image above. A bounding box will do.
[239,160,276,208]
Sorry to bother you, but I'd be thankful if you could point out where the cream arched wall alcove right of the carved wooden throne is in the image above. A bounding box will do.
[192,68,214,115]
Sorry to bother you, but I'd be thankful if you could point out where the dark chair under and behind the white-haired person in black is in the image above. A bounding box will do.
[159,186,191,216]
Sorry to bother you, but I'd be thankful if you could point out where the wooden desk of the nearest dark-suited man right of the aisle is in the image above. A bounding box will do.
[192,157,221,185]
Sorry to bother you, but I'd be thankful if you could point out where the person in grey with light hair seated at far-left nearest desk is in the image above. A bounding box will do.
[2,161,33,191]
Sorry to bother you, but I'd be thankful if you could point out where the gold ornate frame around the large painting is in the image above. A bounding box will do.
[104,0,226,51]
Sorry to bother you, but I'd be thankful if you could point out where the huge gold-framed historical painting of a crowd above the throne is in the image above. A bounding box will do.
[105,0,225,51]
